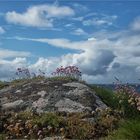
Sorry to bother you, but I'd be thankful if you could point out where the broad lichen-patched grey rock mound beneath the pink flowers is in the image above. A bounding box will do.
[0,80,107,112]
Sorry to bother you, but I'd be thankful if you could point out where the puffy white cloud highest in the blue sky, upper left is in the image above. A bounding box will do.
[5,5,75,27]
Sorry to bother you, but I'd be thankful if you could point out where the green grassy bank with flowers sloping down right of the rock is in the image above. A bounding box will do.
[92,86,140,140]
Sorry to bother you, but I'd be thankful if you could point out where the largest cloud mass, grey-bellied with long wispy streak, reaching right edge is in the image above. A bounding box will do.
[10,24,140,83]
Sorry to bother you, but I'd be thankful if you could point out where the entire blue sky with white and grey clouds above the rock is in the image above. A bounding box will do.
[0,0,140,83]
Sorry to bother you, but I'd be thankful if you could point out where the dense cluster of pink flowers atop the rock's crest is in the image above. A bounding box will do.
[52,66,82,79]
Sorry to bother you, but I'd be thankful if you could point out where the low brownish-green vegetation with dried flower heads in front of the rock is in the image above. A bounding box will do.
[0,108,119,140]
